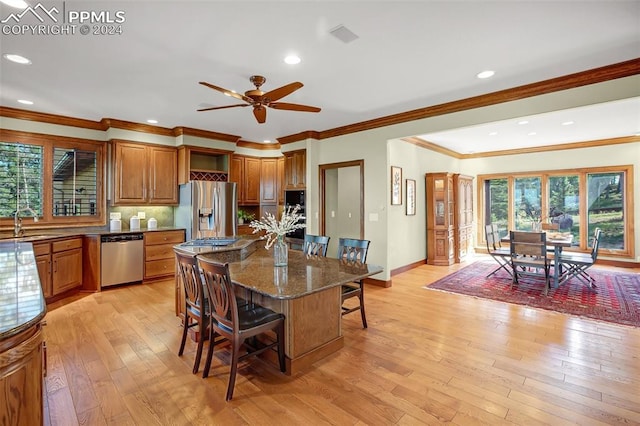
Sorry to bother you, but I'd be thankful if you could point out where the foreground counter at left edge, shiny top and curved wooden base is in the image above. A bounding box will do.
[0,241,47,425]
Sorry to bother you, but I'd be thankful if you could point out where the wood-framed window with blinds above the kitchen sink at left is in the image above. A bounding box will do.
[0,129,106,227]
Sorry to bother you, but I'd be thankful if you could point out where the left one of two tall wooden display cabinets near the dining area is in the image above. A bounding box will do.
[425,173,455,265]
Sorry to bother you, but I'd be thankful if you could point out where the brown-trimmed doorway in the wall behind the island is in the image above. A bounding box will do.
[319,160,364,257]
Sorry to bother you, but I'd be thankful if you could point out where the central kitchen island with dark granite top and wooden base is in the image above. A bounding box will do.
[175,241,382,374]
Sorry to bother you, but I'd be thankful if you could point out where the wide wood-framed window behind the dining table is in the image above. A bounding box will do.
[478,166,634,257]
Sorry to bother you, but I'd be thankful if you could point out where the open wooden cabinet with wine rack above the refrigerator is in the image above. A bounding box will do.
[178,145,231,185]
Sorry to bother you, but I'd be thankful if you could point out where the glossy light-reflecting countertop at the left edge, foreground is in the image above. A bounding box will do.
[0,241,47,341]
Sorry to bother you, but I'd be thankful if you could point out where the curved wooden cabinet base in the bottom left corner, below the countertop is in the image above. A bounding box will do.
[0,323,44,426]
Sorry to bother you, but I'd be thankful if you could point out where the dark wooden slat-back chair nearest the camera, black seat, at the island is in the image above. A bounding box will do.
[198,258,286,401]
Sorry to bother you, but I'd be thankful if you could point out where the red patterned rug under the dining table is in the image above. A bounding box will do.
[424,261,640,327]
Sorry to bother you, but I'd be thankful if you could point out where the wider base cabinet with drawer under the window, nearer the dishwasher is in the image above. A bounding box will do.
[51,237,82,296]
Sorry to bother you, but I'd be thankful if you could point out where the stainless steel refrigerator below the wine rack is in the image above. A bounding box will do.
[175,180,238,241]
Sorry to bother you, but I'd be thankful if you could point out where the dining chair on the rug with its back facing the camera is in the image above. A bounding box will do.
[509,231,551,295]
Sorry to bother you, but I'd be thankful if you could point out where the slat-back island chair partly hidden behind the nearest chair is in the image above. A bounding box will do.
[175,251,209,374]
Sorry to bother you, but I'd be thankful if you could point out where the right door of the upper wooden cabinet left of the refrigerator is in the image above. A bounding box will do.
[147,147,178,204]
